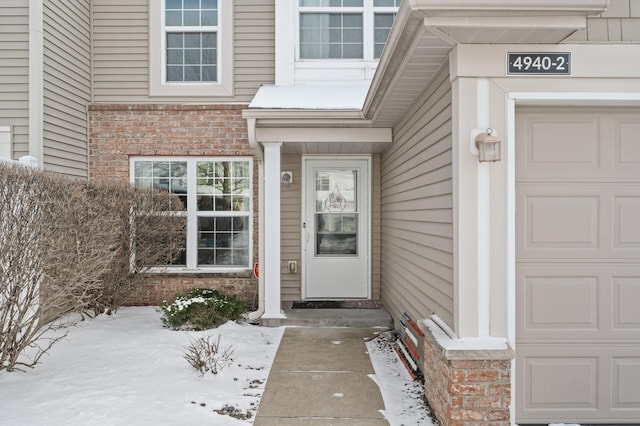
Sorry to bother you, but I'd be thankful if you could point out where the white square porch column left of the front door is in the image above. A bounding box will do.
[262,142,283,318]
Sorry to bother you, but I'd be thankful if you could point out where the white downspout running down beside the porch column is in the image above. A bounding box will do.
[247,118,264,321]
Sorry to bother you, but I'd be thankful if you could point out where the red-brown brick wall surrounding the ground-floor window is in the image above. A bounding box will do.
[89,104,258,305]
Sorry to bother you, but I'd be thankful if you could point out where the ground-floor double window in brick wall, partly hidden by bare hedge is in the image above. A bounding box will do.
[131,157,253,272]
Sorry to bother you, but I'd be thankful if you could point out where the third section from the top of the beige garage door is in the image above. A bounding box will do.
[516,264,640,340]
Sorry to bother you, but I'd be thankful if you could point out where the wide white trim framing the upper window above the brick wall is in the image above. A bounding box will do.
[149,0,234,97]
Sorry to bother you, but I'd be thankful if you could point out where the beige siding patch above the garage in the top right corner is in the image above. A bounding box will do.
[566,0,640,43]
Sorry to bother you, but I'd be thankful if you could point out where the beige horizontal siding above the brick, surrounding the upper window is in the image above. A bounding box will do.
[93,0,275,103]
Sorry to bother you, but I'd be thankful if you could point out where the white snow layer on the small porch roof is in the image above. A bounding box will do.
[249,82,369,110]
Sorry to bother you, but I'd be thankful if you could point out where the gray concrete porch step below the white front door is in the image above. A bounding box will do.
[260,301,393,329]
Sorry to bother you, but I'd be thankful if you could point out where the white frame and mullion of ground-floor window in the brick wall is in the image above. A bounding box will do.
[129,156,254,274]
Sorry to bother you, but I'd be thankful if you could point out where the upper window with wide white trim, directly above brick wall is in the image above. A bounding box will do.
[149,0,233,97]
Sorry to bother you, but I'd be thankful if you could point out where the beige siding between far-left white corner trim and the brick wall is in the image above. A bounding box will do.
[43,0,91,177]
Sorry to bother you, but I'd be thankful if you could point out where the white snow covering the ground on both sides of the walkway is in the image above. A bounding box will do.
[0,307,432,426]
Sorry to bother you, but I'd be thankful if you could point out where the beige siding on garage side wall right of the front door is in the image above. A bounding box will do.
[381,64,453,326]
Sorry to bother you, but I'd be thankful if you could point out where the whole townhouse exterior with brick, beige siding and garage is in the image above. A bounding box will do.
[0,0,640,425]
